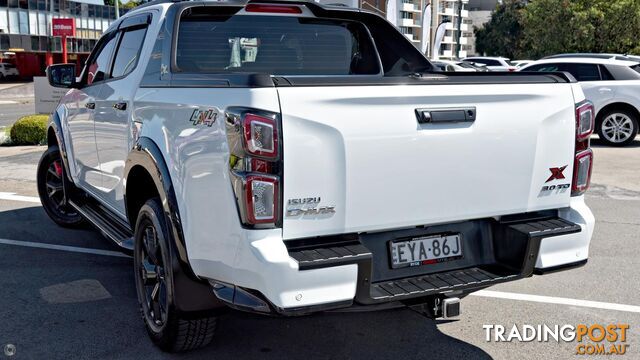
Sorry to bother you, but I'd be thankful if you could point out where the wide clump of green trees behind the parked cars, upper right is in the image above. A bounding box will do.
[474,0,640,58]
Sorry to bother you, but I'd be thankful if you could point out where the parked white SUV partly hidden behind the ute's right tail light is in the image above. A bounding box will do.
[520,58,640,146]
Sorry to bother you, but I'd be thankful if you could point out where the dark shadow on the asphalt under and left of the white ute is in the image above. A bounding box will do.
[0,207,490,360]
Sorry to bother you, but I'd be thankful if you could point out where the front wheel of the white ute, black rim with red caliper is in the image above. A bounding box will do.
[36,146,84,227]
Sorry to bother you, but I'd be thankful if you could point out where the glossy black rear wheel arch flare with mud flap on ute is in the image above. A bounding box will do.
[124,136,224,313]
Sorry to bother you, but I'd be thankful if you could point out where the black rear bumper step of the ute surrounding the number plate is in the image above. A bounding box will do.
[285,212,582,305]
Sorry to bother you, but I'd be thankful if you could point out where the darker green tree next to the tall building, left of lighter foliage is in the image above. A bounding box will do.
[473,0,526,59]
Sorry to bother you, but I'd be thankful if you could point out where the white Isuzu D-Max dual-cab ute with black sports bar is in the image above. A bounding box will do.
[38,1,594,351]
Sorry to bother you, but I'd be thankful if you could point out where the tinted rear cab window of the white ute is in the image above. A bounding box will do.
[174,9,382,76]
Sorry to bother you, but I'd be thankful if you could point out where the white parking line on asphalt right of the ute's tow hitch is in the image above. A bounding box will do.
[471,290,640,313]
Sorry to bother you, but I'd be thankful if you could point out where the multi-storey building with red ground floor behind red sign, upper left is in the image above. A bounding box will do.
[0,0,122,77]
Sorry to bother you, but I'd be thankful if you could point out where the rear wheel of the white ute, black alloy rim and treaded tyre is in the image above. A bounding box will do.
[134,198,217,352]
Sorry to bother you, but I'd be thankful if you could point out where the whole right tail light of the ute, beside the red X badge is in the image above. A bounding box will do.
[571,100,595,196]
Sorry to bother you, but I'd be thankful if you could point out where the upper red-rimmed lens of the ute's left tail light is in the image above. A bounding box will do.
[243,114,278,160]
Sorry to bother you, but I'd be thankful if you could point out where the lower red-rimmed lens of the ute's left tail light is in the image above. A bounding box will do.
[245,175,278,224]
